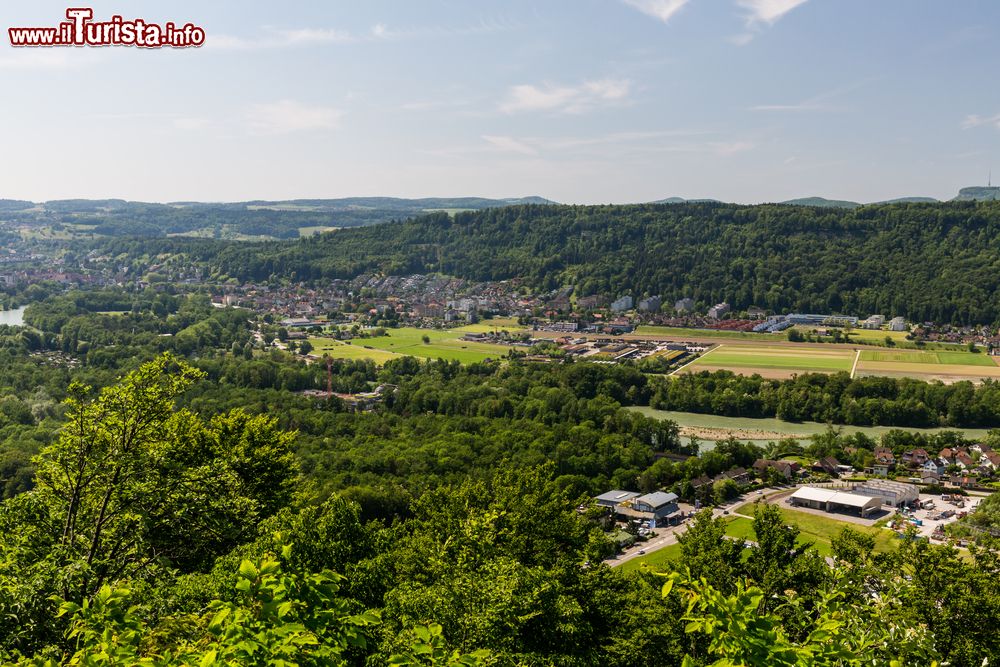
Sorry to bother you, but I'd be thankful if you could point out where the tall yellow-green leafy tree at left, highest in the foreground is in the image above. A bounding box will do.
[0,355,295,650]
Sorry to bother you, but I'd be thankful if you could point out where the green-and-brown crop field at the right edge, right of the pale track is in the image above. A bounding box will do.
[856,350,1000,382]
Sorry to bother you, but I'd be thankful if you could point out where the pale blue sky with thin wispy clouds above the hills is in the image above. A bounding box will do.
[0,0,1000,204]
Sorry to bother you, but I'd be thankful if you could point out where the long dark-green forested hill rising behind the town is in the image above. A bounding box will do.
[129,202,1000,323]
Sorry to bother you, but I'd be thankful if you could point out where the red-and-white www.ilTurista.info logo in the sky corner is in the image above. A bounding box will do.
[7,7,205,49]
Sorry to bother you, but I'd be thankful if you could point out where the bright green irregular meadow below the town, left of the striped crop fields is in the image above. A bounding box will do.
[309,327,511,363]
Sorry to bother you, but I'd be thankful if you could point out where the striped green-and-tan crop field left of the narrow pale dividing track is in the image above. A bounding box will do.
[680,344,855,378]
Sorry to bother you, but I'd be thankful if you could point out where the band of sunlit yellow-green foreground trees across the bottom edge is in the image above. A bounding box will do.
[7,356,1000,667]
